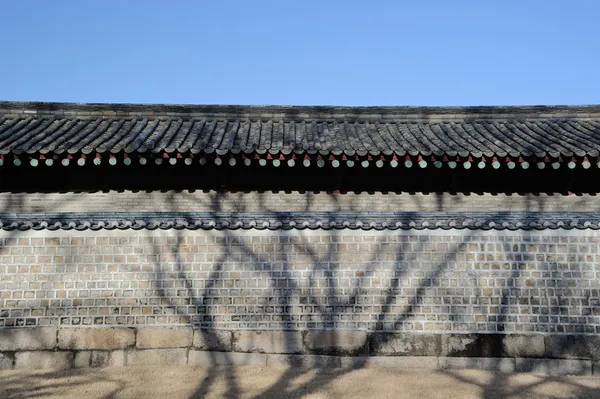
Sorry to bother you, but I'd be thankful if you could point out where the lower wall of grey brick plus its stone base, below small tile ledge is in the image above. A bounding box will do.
[0,229,600,373]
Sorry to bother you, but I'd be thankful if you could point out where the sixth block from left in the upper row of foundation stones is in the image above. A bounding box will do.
[305,330,368,355]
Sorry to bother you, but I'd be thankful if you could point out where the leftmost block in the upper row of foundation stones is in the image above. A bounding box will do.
[0,327,58,351]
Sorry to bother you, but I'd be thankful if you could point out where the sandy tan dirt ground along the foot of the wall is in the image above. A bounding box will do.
[0,366,600,398]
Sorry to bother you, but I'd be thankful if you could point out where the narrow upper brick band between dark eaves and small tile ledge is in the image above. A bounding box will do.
[0,191,600,213]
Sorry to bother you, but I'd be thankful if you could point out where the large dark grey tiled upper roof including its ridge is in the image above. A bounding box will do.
[0,102,600,167]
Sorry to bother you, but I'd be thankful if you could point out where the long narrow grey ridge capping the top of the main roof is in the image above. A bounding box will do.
[0,101,600,120]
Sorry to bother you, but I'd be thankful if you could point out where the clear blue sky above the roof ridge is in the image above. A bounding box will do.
[0,0,600,105]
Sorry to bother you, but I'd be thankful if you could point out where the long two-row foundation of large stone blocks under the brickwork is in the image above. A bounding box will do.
[0,326,600,375]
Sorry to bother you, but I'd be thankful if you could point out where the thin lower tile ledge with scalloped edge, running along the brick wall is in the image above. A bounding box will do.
[0,212,600,230]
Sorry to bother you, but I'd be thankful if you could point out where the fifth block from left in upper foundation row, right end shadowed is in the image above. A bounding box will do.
[233,331,302,353]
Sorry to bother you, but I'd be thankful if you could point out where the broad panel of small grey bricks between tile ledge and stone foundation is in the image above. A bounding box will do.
[0,230,600,334]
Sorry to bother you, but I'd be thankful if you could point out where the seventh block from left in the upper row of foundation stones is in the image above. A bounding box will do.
[369,333,442,356]
